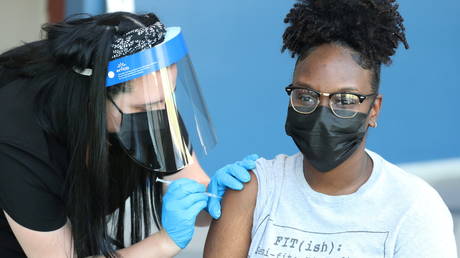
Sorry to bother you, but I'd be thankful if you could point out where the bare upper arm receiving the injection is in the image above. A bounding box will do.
[204,171,257,258]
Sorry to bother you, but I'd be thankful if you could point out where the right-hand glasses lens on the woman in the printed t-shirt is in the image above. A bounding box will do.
[331,93,360,118]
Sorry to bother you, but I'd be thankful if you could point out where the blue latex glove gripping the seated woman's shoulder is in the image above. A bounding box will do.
[208,154,259,219]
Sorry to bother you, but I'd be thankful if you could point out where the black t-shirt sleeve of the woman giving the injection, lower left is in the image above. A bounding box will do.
[0,143,67,231]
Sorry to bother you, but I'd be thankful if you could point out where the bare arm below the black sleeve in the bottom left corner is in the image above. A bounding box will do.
[4,212,73,258]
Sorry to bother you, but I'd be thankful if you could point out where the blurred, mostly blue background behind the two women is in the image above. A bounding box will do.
[0,0,460,257]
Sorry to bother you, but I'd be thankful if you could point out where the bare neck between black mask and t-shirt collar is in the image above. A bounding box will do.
[303,144,373,195]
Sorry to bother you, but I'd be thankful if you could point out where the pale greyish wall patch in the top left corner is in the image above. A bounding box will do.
[0,0,47,52]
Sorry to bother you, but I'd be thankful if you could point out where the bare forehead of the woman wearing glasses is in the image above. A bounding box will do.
[294,44,372,93]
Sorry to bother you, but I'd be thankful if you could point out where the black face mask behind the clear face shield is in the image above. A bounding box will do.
[109,110,191,174]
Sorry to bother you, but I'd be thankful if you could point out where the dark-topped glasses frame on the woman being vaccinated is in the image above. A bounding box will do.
[284,83,377,119]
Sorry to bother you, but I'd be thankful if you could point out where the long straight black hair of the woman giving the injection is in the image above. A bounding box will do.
[0,12,161,257]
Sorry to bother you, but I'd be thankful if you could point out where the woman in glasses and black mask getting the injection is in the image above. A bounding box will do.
[204,0,456,258]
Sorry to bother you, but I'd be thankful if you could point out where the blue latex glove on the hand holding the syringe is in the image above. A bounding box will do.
[161,178,209,249]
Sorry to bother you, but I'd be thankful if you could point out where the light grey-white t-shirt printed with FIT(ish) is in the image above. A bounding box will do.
[248,150,457,258]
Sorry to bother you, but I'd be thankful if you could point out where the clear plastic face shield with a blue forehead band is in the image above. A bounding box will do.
[106,27,216,175]
